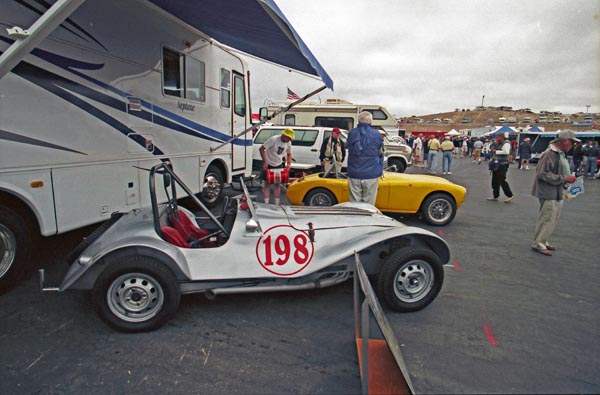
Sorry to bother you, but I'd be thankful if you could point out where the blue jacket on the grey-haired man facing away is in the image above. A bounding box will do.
[346,123,383,180]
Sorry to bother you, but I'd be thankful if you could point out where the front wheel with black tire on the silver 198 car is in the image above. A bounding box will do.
[377,247,444,312]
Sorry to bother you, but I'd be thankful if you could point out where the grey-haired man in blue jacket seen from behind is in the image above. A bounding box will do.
[346,111,383,205]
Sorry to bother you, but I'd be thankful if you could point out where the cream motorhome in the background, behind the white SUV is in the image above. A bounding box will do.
[260,99,398,137]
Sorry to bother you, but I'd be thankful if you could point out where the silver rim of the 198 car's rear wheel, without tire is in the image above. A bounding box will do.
[107,273,164,322]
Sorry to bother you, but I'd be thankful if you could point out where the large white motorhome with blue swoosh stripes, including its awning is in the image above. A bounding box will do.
[0,0,332,290]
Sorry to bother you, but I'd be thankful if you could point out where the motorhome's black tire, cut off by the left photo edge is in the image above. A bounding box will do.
[0,206,33,294]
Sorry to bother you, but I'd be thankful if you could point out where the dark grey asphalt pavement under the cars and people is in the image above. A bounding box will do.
[0,159,600,395]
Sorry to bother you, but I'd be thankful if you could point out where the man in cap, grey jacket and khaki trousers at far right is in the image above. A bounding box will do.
[531,129,580,256]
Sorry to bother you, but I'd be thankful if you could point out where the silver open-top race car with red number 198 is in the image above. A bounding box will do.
[41,164,450,332]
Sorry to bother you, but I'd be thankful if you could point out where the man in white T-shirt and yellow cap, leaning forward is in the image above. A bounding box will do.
[258,128,294,204]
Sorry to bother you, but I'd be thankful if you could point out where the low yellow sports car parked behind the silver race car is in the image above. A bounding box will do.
[286,172,467,226]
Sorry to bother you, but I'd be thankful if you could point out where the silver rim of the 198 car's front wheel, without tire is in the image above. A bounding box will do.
[394,260,435,303]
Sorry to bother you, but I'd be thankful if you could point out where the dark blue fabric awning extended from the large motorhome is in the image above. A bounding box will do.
[149,0,333,90]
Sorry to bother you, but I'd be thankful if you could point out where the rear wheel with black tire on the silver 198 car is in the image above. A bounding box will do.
[92,256,180,332]
